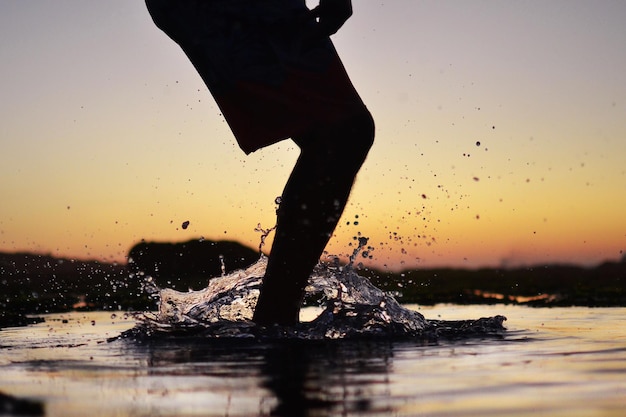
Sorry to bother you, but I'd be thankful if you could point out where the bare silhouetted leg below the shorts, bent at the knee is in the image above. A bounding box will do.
[253,110,374,325]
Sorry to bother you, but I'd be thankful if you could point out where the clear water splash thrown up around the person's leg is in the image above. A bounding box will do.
[123,239,506,340]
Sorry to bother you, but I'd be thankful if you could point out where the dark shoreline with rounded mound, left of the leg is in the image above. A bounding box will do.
[0,240,260,328]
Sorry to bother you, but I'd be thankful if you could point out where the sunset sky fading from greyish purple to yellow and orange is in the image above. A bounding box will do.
[0,0,626,269]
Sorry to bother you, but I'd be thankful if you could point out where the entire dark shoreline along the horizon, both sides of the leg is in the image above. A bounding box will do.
[0,240,626,328]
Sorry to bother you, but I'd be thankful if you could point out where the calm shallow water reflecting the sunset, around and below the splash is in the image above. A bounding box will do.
[0,305,626,417]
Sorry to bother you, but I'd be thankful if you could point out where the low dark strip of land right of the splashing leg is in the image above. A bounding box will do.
[361,261,626,307]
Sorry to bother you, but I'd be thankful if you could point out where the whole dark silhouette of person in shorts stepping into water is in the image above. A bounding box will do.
[146,0,374,325]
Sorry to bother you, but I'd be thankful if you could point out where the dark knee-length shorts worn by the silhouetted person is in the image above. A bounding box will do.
[146,0,365,153]
